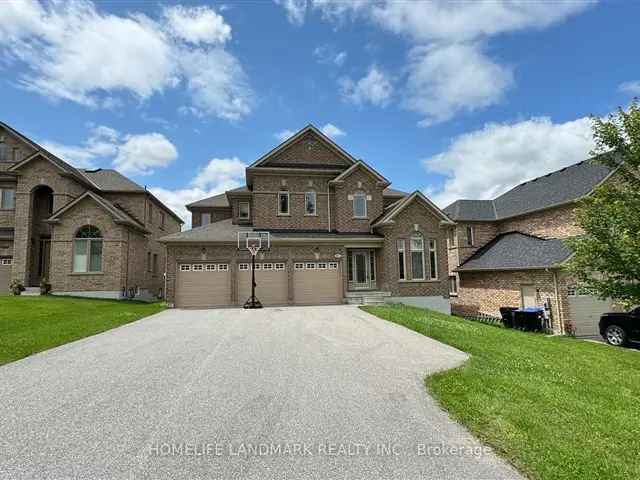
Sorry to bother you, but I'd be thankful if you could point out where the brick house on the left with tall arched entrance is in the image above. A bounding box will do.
[0,123,183,298]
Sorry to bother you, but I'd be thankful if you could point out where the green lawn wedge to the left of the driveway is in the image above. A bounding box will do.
[0,296,164,365]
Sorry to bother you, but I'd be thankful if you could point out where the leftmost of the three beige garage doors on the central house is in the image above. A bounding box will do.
[176,263,231,308]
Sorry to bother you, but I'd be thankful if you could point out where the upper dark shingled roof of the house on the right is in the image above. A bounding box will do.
[444,159,612,221]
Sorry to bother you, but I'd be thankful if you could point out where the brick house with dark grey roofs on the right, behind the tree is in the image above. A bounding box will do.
[444,160,612,335]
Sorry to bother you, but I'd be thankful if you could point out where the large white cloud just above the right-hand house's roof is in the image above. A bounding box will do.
[424,117,594,207]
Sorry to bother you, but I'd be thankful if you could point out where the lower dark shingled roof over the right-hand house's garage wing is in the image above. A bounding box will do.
[456,232,571,272]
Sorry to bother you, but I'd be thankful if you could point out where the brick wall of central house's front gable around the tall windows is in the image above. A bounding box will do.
[378,201,449,297]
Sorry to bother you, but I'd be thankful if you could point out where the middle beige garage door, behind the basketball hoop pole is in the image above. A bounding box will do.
[238,262,289,305]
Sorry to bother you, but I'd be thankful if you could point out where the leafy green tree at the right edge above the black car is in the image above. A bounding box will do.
[568,99,640,306]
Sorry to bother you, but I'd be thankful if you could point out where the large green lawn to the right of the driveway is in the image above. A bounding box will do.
[362,305,640,480]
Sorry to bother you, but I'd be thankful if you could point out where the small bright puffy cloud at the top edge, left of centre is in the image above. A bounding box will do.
[164,5,231,44]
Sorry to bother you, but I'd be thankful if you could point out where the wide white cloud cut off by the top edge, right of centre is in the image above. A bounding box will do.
[313,0,596,43]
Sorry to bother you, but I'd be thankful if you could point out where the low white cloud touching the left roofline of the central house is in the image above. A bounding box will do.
[150,157,247,229]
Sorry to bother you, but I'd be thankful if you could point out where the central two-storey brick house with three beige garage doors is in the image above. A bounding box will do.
[160,125,453,312]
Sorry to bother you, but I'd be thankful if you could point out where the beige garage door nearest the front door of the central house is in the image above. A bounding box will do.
[293,262,342,305]
